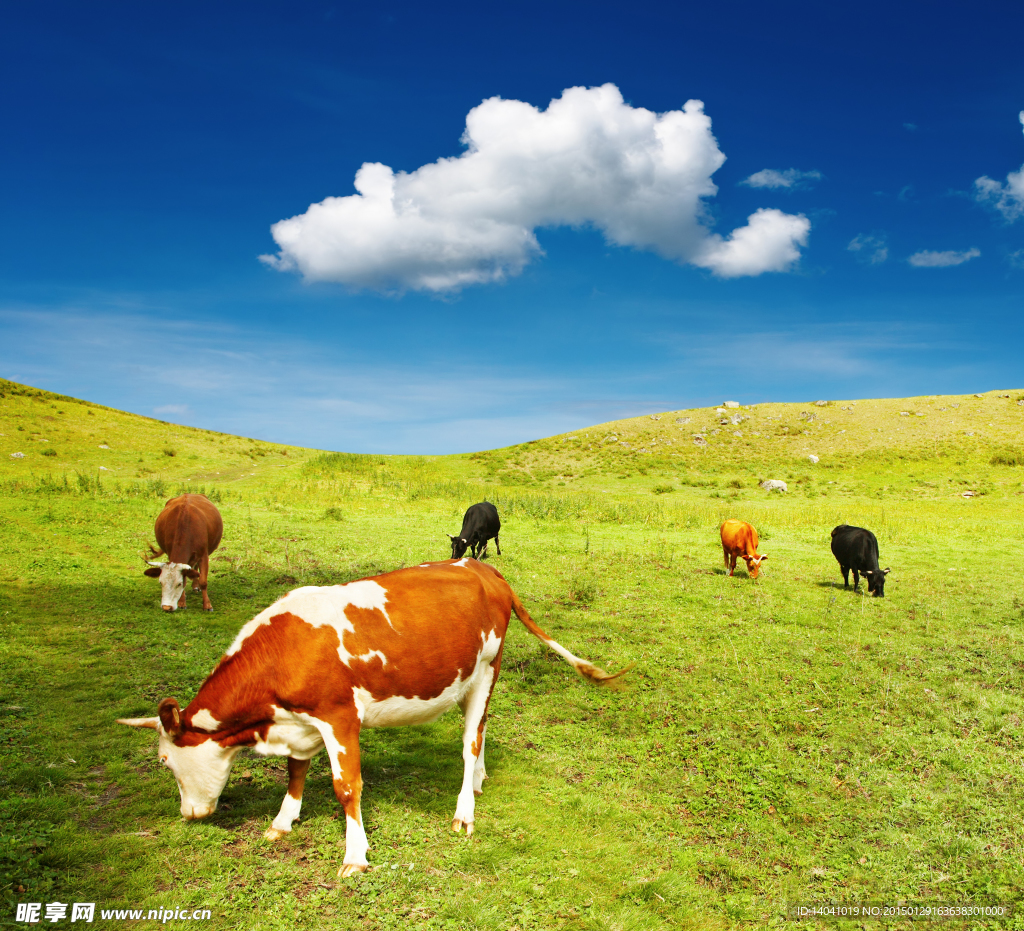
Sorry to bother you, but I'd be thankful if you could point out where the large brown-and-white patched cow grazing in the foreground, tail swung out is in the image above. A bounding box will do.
[119,559,626,877]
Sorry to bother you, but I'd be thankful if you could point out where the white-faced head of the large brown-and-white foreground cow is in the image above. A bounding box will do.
[118,699,239,821]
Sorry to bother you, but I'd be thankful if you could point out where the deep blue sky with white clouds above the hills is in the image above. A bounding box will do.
[0,2,1024,453]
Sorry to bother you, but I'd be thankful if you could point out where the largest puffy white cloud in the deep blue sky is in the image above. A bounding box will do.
[261,84,810,292]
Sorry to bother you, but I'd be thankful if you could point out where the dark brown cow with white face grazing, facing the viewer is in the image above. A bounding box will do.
[143,495,224,611]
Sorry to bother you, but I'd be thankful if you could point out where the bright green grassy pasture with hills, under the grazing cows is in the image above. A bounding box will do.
[0,382,1024,929]
